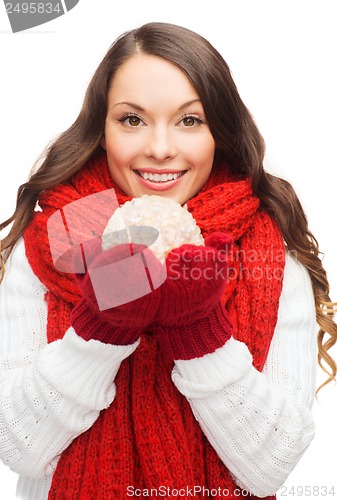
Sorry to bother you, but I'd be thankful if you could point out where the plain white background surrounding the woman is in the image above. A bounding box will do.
[0,0,337,500]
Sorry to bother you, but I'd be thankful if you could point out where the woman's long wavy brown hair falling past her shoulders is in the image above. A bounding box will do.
[0,23,337,387]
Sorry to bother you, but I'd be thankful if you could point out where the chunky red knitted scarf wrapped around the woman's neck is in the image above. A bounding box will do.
[24,152,285,500]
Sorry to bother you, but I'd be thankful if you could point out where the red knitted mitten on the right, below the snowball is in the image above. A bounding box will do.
[153,233,232,360]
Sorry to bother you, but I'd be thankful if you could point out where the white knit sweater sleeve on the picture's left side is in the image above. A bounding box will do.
[0,240,138,478]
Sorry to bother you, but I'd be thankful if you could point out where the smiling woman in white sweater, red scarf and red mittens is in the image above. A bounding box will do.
[0,23,337,499]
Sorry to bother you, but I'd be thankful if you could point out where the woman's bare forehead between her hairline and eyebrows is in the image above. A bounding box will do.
[109,54,199,103]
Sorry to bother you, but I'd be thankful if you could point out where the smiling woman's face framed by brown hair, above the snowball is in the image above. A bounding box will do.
[101,55,215,204]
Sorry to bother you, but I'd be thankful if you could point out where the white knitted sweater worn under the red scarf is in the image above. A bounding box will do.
[0,240,317,500]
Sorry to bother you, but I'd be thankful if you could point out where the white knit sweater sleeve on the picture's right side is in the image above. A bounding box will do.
[172,254,317,497]
